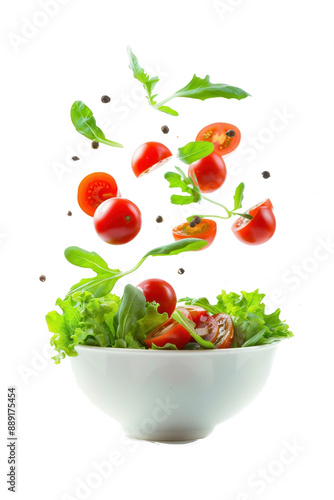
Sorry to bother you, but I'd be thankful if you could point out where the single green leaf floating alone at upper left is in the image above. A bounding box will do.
[71,101,123,148]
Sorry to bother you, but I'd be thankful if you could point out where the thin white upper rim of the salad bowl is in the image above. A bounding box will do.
[73,341,281,359]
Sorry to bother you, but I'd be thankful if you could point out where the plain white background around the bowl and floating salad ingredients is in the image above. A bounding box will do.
[0,0,334,500]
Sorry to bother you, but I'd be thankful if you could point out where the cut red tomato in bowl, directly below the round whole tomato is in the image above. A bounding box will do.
[144,308,191,349]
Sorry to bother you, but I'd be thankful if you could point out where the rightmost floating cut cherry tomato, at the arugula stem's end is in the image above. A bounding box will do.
[232,199,276,245]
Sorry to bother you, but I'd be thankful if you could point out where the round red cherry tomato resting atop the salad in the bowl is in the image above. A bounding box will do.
[137,278,177,316]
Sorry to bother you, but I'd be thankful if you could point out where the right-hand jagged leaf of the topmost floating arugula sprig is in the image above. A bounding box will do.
[173,75,250,101]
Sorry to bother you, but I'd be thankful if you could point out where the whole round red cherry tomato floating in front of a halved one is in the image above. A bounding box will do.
[94,198,141,245]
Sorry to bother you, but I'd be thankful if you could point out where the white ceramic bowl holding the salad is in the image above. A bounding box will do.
[71,344,278,441]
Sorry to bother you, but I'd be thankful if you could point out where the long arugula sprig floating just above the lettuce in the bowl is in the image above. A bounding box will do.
[65,238,207,297]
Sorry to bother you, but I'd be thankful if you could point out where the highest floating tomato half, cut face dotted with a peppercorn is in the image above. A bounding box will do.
[196,122,241,156]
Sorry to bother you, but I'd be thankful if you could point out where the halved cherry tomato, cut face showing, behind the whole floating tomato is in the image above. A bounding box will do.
[78,172,118,217]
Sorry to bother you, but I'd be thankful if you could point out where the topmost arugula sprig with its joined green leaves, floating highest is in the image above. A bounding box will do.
[128,47,250,116]
